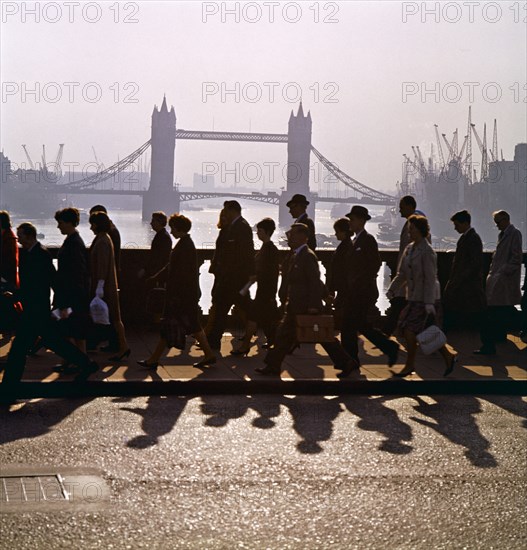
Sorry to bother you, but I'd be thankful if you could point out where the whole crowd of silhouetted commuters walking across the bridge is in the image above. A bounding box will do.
[0,194,527,392]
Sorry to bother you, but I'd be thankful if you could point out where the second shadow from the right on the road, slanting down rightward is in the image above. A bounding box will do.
[340,395,413,455]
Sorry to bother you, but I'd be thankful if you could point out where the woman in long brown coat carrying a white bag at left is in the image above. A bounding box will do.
[90,212,130,361]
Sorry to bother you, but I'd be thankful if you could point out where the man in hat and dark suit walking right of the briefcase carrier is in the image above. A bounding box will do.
[341,205,399,366]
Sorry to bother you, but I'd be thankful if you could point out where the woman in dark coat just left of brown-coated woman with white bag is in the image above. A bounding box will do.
[53,208,91,370]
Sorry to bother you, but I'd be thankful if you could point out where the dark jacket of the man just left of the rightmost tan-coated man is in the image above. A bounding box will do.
[443,227,485,313]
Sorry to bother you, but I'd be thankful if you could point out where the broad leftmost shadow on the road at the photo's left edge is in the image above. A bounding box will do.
[0,397,93,445]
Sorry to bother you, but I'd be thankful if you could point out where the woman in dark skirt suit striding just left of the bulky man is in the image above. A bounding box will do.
[138,214,216,369]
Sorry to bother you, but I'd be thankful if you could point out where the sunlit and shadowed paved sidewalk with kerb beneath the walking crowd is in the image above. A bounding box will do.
[0,327,527,397]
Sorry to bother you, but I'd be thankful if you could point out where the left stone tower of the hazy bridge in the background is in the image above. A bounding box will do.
[143,97,180,221]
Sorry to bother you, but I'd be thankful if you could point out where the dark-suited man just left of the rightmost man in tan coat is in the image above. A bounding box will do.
[443,210,485,330]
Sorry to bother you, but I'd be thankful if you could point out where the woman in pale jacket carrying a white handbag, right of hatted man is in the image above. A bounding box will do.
[386,214,457,377]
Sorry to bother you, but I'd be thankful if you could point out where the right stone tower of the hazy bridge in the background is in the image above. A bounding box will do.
[278,101,315,226]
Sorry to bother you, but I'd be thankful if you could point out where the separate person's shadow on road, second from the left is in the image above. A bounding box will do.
[121,395,192,449]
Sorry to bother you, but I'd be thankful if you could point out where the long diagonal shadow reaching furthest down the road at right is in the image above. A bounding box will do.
[410,395,498,468]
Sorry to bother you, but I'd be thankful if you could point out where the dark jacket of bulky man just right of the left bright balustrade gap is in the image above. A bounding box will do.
[211,217,255,289]
